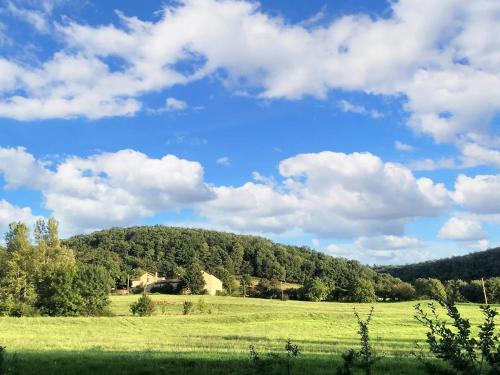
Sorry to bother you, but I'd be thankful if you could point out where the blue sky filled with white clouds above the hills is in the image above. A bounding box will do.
[0,0,500,264]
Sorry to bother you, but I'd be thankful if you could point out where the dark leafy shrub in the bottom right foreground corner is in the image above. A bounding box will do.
[415,300,500,375]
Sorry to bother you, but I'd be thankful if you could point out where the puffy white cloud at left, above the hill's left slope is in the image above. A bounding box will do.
[0,149,212,232]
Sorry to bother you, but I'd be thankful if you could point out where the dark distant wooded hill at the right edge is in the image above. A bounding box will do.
[377,247,500,281]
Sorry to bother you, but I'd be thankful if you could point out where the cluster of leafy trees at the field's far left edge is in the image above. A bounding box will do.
[0,219,113,316]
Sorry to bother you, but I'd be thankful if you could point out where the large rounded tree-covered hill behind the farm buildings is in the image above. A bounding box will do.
[64,226,375,288]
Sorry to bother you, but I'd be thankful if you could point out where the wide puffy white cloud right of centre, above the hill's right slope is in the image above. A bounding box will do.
[199,152,450,237]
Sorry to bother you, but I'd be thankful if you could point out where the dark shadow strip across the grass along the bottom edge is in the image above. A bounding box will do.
[0,349,430,375]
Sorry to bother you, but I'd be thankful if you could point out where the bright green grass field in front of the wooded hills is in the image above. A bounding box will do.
[0,295,500,374]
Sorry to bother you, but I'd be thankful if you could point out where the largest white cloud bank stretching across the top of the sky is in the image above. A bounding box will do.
[0,0,500,156]
